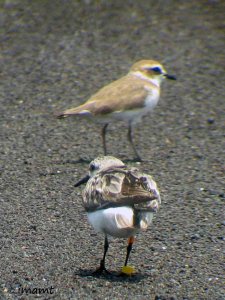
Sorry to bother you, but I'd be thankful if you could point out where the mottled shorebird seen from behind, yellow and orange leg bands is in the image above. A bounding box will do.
[75,156,161,275]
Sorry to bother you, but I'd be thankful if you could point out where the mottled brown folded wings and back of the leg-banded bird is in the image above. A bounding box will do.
[83,169,160,210]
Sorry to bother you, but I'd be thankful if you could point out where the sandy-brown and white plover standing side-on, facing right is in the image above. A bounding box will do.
[57,60,176,160]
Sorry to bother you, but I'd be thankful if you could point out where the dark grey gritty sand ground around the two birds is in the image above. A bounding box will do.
[0,0,225,300]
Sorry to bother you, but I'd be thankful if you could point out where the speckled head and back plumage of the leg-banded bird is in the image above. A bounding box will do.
[78,156,161,236]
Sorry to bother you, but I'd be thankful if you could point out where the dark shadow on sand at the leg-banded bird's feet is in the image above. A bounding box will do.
[74,269,150,283]
